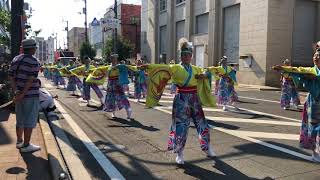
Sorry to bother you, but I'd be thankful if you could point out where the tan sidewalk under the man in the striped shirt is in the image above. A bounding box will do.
[0,113,51,180]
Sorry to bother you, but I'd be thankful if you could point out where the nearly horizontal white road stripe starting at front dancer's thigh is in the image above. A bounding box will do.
[206,116,301,127]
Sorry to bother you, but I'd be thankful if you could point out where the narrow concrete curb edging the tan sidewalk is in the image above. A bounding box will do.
[39,113,70,180]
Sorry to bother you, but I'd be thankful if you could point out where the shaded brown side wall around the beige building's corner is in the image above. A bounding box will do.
[266,0,295,85]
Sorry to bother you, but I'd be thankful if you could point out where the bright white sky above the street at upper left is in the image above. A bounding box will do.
[25,0,141,48]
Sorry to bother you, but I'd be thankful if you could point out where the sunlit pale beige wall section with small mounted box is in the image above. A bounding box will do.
[238,0,268,85]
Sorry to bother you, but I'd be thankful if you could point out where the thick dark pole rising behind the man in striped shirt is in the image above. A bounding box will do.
[11,0,24,59]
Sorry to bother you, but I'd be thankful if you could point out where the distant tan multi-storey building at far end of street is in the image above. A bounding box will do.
[67,27,86,57]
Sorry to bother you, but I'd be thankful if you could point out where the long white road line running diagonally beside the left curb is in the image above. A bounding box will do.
[55,101,125,180]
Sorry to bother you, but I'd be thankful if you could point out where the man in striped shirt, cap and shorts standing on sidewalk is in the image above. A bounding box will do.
[9,39,40,153]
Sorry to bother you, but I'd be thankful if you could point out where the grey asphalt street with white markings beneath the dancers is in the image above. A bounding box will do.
[43,78,320,180]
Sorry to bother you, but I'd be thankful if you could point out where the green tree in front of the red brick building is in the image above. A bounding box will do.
[103,37,134,60]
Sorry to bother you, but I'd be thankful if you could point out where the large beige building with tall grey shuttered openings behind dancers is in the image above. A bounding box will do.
[141,0,320,85]
